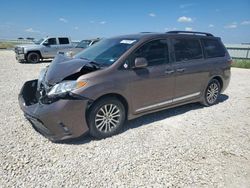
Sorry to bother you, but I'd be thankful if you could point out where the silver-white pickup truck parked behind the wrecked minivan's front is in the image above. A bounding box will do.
[15,37,74,63]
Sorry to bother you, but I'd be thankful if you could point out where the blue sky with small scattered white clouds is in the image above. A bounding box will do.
[0,0,250,43]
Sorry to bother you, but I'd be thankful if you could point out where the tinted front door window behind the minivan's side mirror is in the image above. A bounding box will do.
[135,40,169,66]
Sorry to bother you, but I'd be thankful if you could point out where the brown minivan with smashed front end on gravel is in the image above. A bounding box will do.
[19,31,231,141]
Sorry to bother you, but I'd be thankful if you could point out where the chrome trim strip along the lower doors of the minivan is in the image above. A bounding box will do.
[135,92,201,112]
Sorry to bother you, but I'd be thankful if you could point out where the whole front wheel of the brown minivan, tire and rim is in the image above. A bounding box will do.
[87,97,126,139]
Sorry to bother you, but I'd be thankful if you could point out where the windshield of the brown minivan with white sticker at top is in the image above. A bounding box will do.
[75,38,137,66]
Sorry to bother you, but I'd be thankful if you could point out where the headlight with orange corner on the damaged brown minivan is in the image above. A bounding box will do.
[48,81,87,97]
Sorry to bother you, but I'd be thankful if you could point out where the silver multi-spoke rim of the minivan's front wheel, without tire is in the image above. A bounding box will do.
[95,104,121,132]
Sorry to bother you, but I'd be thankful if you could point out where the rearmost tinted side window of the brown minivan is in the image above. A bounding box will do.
[202,39,225,58]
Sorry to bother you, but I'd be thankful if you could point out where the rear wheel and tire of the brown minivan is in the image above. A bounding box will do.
[202,79,221,106]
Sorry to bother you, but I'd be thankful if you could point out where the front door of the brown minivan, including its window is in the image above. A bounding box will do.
[129,39,174,113]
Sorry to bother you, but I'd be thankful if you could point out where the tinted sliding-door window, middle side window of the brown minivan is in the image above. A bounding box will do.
[173,39,202,61]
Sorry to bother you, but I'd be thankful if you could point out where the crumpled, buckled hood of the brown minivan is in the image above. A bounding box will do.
[45,54,92,85]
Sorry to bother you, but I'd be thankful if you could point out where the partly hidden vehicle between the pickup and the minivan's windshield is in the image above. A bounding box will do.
[59,38,101,57]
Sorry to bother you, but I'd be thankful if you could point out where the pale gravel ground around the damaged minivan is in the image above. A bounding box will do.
[0,51,250,187]
